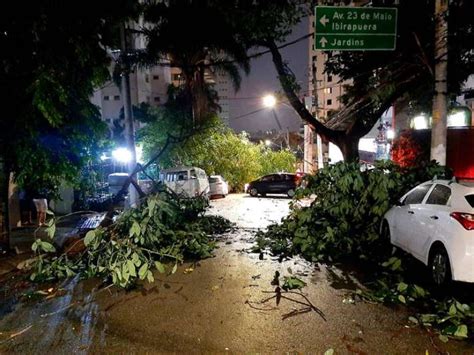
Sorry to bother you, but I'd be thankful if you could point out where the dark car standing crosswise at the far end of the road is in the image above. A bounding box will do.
[246,173,301,197]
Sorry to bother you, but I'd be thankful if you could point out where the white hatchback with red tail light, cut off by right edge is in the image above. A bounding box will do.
[381,180,474,285]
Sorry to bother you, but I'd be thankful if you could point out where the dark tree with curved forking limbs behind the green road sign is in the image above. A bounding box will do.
[267,0,474,160]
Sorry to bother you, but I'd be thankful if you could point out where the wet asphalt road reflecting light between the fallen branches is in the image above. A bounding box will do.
[0,195,474,354]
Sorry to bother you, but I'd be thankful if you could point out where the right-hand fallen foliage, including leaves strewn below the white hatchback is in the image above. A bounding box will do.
[255,162,474,341]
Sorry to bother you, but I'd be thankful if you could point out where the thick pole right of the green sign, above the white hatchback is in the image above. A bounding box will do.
[431,0,448,165]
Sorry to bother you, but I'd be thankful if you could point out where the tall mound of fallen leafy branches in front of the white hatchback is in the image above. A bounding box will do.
[257,162,445,261]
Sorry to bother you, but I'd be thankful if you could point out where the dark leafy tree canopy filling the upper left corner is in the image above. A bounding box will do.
[0,0,139,195]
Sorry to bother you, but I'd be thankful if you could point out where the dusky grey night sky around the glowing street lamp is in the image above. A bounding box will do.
[229,19,309,136]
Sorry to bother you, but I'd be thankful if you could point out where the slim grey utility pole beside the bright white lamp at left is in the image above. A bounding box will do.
[120,24,138,206]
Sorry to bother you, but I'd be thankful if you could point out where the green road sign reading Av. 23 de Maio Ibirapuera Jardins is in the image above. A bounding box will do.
[314,6,397,50]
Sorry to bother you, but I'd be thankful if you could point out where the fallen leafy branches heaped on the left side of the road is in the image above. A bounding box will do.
[31,192,231,287]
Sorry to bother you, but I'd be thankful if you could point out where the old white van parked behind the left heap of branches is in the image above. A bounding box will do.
[160,166,209,198]
